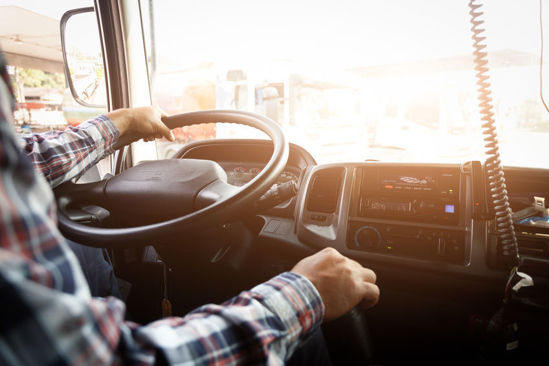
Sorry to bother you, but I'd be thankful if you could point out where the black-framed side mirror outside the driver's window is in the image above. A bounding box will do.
[61,7,107,108]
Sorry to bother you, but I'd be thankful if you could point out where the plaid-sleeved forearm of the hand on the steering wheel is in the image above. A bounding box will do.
[22,116,120,187]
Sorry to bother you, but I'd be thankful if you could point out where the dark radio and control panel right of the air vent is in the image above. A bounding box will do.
[346,166,466,263]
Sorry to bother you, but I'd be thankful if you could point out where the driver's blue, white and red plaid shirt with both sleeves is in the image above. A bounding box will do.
[0,82,324,365]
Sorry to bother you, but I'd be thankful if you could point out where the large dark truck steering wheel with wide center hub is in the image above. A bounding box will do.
[55,110,289,248]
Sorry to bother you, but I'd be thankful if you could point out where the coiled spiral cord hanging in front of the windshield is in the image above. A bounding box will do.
[469,0,519,265]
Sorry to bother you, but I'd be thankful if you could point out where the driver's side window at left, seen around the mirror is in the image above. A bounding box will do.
[0,0,110,180]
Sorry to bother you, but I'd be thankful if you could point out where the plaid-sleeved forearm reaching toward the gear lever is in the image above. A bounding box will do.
[136,273,324,365]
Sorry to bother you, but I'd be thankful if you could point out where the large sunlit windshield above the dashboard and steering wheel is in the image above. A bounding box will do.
[142,0,549,168]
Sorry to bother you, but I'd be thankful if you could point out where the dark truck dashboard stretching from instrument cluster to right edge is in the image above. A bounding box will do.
[175,140,549,280]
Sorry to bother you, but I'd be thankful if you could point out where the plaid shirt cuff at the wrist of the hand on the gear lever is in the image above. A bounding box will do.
[251,272,324,338]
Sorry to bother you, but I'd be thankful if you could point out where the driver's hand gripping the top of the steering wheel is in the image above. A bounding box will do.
[107,107,175,141]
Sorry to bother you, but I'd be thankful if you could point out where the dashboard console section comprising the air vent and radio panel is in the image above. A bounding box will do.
[297,163,472,266]
